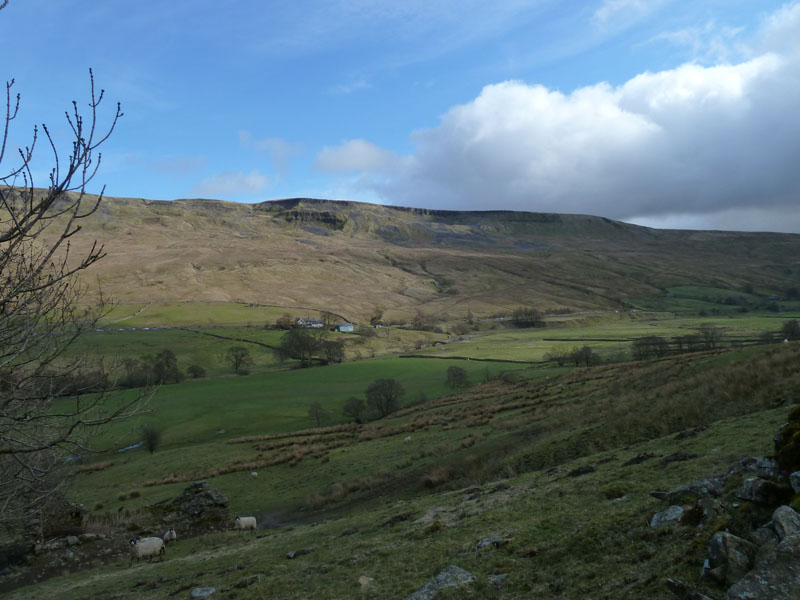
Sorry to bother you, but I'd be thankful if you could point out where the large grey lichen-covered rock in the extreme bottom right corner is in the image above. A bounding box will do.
[727,536,800,600]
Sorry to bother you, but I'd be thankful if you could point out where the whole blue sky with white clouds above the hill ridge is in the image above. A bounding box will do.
[0,0,800,233]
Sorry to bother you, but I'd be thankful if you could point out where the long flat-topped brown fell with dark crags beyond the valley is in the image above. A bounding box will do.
[54,193,800,321]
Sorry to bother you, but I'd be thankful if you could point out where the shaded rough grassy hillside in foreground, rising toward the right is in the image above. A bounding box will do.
[9,344,800,600]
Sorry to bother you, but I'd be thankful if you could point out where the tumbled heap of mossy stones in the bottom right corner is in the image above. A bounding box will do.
[650,408,800,600]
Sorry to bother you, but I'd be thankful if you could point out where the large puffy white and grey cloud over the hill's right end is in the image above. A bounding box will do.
[324,5,800,230]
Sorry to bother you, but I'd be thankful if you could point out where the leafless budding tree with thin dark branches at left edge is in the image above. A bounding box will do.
[0,70,142,530]
